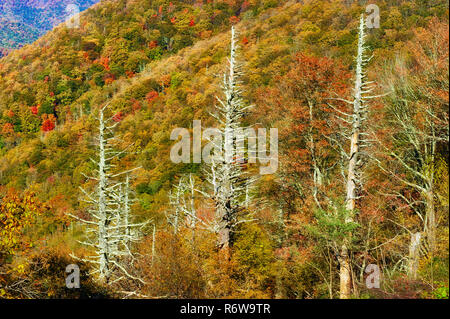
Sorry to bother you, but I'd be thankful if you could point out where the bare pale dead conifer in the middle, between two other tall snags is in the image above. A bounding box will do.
[208,27,255,249]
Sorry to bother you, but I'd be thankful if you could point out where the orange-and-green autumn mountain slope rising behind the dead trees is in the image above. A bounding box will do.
[0,1,445,222]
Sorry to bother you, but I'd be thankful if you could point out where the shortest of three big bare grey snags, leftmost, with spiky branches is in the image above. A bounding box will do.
[70,106,146,283]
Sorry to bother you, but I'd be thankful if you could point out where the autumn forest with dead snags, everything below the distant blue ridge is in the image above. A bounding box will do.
[0,0,449,299]
